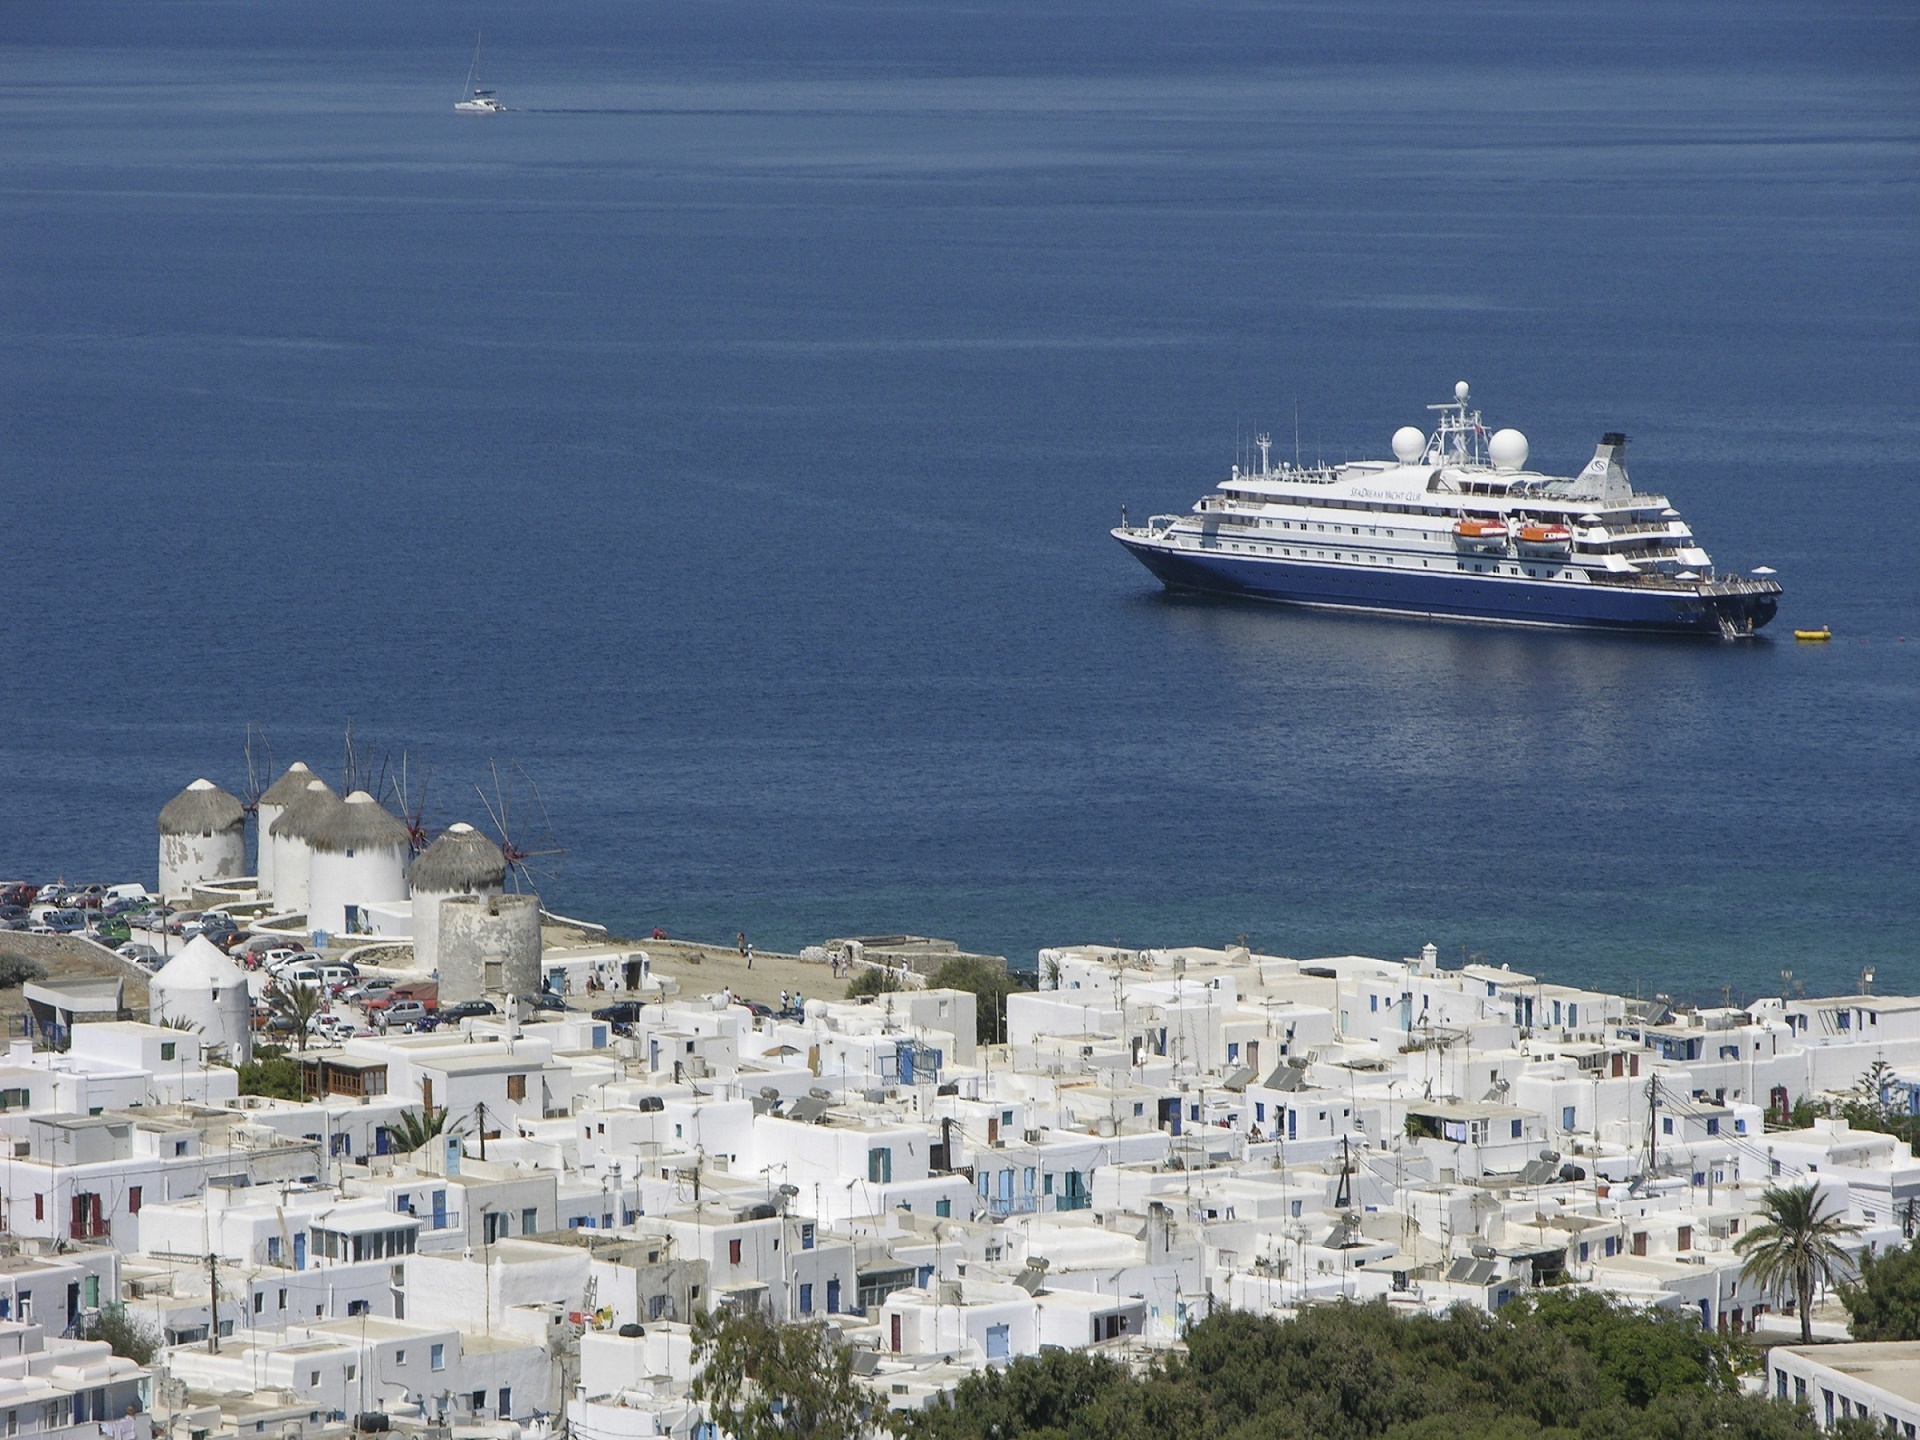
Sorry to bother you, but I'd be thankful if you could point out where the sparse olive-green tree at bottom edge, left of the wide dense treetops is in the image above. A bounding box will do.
[693,1311,866,1440]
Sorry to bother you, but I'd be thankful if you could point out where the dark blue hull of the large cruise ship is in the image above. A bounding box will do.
[1119,536,1778,636]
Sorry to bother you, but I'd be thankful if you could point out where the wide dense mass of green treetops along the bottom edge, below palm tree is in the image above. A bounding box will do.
[885,1313,1870,1440]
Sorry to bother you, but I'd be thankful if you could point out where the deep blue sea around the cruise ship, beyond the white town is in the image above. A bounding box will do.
[0,0,1920,996]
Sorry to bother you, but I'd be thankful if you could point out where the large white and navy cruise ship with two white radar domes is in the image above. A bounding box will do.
[1114,380,1780,639]
